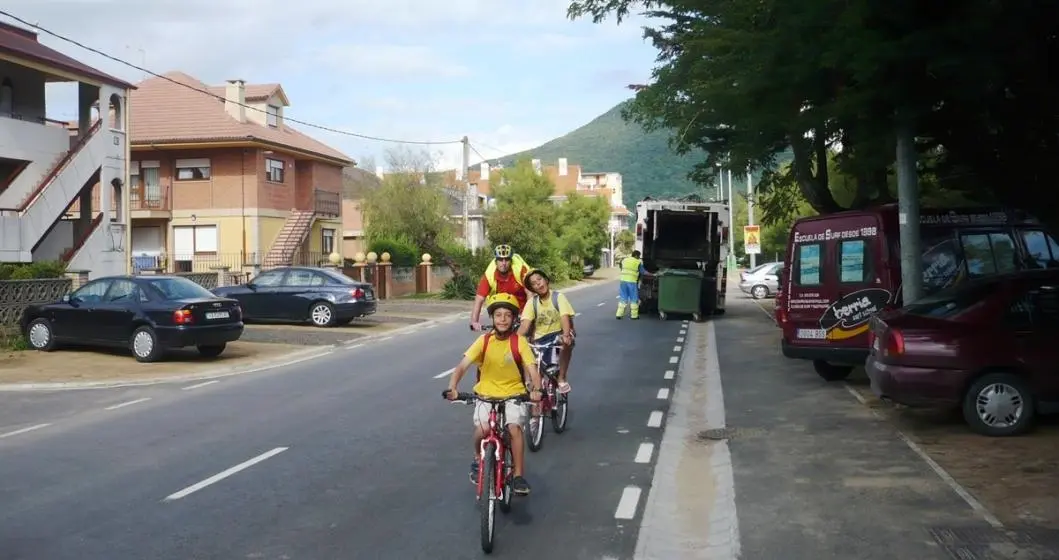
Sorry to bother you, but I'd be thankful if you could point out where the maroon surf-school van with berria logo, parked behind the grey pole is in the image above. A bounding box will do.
[776,204,1059,381]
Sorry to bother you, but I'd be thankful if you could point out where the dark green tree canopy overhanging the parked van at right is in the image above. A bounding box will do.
[569,0,1059,230]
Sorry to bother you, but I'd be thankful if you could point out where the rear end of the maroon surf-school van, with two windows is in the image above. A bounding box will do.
[784,213,893,355]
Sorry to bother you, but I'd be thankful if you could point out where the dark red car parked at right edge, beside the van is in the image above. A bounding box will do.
[865,269,1059,436]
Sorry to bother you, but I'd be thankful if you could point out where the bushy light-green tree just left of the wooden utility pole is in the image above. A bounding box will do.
[362,148,452,255]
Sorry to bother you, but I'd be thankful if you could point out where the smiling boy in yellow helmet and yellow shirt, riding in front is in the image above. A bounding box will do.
[448,293,540,495]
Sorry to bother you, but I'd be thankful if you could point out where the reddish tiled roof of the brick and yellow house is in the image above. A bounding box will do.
[129,72,353,164]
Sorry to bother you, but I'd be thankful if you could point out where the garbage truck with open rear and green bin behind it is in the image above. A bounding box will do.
[635,195,730,321]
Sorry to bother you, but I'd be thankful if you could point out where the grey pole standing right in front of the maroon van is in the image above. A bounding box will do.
[897,114,923,305]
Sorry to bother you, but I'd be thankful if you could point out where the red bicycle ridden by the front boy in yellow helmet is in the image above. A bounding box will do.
[442,391,530,554]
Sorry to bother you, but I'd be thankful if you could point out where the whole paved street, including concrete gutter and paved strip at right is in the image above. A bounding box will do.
[0,283,1025,560]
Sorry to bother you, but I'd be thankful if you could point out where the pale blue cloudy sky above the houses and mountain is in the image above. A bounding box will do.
[0,0,657,168]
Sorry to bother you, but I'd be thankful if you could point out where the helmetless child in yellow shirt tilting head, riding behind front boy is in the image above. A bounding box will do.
[519,269,575,393]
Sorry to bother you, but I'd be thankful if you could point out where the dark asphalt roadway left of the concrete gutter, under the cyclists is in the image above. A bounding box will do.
[0,283,681,560]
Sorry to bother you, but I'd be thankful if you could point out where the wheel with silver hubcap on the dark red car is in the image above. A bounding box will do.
[964,373,1037,437]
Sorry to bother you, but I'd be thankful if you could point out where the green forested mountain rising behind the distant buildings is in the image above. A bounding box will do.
[487,102,713,209]
